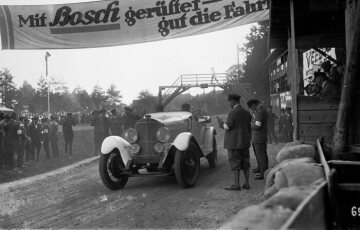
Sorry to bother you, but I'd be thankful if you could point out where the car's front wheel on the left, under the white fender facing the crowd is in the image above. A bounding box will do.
[99,151,129,190]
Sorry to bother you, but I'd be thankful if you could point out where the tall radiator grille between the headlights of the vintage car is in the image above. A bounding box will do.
[135,119,163,157]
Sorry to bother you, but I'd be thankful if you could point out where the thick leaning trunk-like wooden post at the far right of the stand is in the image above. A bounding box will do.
[331,0,360,159]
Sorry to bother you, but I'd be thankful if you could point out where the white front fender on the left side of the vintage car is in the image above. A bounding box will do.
[101,136,131,166]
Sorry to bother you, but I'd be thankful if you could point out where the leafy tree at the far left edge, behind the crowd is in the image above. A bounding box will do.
[0,69,17,108]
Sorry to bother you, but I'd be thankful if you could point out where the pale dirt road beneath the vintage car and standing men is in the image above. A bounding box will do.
[0,128,280,229]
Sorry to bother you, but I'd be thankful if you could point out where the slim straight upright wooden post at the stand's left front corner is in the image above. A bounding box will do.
[288,0,299,140]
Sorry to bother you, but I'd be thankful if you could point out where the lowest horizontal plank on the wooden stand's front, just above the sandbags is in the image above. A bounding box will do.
[299,124,335,137]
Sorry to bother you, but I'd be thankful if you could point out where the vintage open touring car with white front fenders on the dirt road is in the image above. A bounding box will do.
[99,112,217,190]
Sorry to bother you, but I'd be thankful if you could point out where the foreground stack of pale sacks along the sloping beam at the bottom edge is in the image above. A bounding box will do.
[221,180,322,229]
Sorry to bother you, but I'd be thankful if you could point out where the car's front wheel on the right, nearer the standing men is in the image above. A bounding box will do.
[174,143,200,188]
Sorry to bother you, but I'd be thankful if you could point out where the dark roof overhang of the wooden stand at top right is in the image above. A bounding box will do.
[269,0,345,49]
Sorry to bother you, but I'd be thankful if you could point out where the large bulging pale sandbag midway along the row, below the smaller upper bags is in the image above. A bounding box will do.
[264,163,325,199]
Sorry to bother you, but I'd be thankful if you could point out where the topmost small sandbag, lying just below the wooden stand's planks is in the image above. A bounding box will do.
[276,144,315,163]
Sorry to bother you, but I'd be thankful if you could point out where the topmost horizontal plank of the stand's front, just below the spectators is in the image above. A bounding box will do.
[298,96,340,111]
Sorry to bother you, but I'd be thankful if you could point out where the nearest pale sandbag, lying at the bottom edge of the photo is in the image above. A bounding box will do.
[220,205,292,230]
